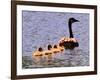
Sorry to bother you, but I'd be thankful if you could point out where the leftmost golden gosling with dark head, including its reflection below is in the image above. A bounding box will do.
[32,47,43,63]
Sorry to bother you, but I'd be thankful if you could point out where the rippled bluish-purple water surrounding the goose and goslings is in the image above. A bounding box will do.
[22,11,89,69]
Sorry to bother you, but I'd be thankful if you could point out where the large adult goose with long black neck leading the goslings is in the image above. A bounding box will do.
[60,18,79,49]
